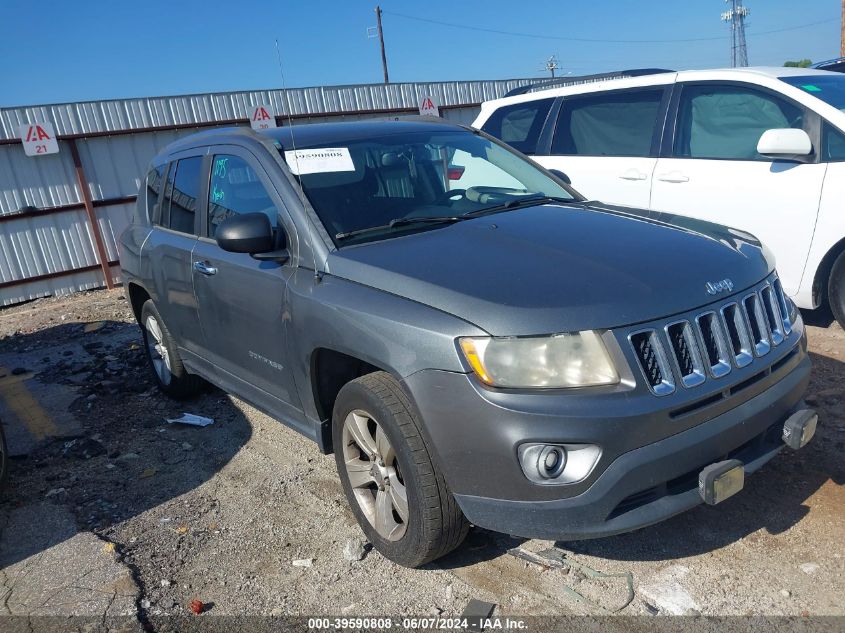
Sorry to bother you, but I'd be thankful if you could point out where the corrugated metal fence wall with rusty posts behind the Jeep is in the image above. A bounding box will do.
[0,79,537,305]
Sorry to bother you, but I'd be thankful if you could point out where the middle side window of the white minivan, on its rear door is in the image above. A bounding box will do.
[552,88,665,156]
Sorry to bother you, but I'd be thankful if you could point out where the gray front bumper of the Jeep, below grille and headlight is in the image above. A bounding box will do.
[406,336,810,540]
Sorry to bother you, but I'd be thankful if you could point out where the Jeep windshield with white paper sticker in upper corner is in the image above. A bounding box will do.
[284,130,575,246]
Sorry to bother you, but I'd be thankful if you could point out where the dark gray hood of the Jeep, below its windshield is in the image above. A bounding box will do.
[327,203,773,336]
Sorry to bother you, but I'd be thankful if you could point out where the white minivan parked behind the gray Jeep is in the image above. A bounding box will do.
[473,68,845,327]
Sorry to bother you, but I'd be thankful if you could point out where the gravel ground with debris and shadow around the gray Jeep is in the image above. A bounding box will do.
[0,291,845,627]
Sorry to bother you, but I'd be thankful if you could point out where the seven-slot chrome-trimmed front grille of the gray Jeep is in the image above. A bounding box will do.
[628,279,792,396]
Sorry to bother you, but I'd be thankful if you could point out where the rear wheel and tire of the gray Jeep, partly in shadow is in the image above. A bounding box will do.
[141,299,205,400]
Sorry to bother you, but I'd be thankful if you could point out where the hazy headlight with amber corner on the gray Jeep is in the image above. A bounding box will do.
[459,330,619,389]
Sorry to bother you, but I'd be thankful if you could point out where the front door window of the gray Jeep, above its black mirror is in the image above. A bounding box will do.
[208,154,278,238]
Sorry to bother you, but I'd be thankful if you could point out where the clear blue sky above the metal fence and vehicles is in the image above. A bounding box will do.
[0,0,841,107]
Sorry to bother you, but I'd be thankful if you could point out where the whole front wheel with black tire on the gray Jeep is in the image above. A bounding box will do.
[332,372,469,567]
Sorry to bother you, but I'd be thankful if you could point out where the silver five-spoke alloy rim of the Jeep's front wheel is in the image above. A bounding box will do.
[343,409,408,541]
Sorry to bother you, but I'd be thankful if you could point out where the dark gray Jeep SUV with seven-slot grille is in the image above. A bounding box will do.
[121,119,817,566]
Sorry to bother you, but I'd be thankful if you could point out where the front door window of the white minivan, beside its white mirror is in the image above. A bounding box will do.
[674,85,804,161]
